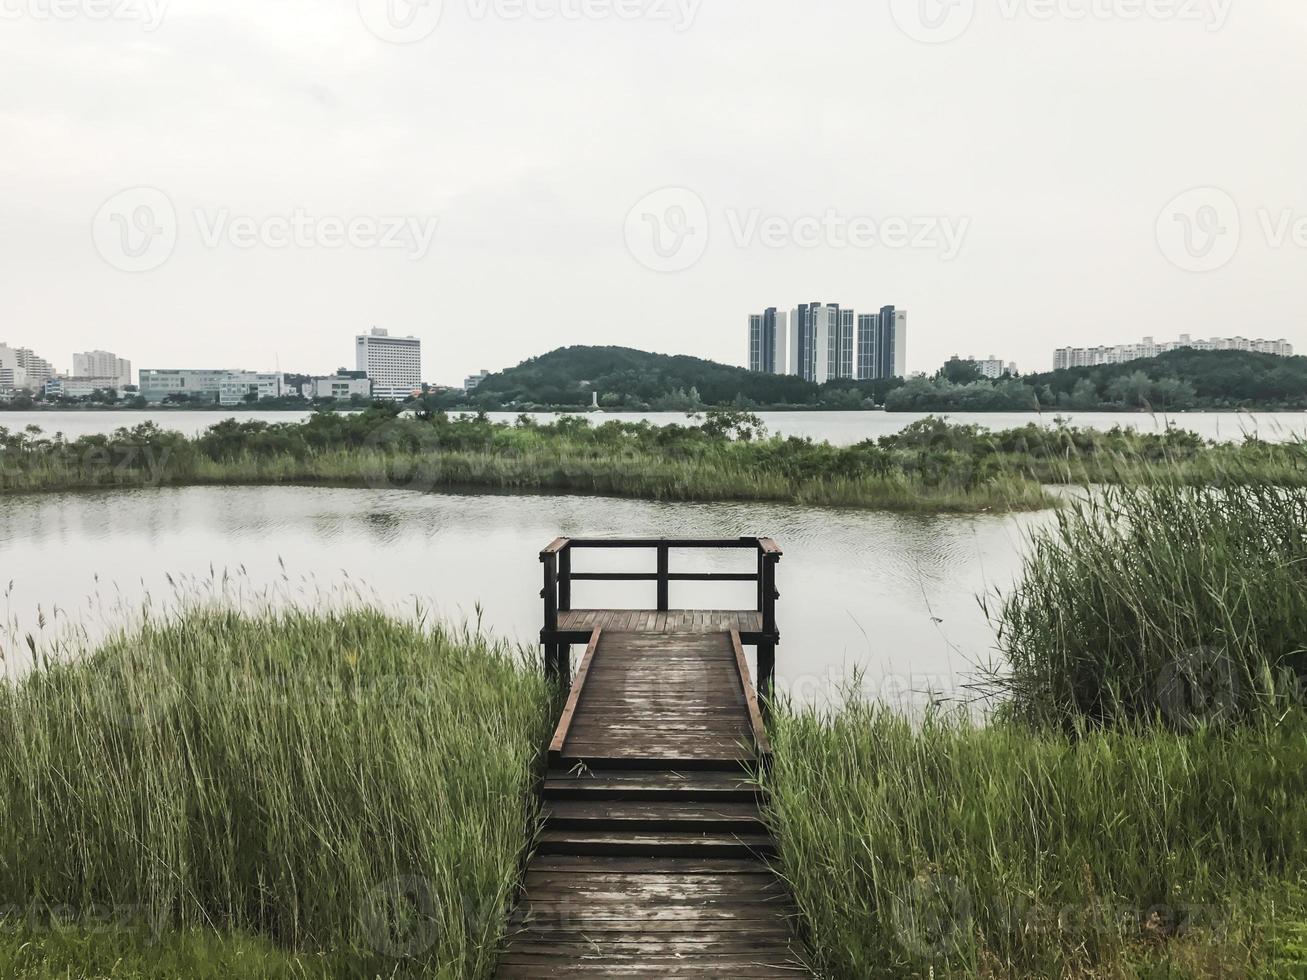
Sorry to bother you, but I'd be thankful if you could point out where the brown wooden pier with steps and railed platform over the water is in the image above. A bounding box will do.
[498,538,812,979]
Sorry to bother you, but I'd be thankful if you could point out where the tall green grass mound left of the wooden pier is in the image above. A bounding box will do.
[0,610,549,979]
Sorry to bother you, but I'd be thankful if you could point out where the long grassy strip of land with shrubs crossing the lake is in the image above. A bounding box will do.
[0,408,1307,512]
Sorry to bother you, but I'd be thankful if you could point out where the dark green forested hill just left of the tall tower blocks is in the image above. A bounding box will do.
[474,346,817,410]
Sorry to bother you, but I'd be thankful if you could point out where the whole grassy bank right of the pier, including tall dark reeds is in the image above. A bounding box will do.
[771,486,1307,980]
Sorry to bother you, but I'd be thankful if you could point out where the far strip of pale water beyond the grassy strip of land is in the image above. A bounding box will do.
[0,410,1307,446]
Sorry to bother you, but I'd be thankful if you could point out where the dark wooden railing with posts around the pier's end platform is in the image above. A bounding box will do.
[540,537,783,698]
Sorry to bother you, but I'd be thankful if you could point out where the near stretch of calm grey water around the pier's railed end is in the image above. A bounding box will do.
[0,487,1050,707]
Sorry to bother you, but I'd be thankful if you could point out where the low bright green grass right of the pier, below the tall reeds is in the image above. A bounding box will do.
[769,703,1307,980]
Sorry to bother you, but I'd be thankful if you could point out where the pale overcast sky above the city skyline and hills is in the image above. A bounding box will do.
[0,0,1307,383]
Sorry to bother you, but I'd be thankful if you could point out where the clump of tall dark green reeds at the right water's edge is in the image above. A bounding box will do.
[995,483,1307,728]
